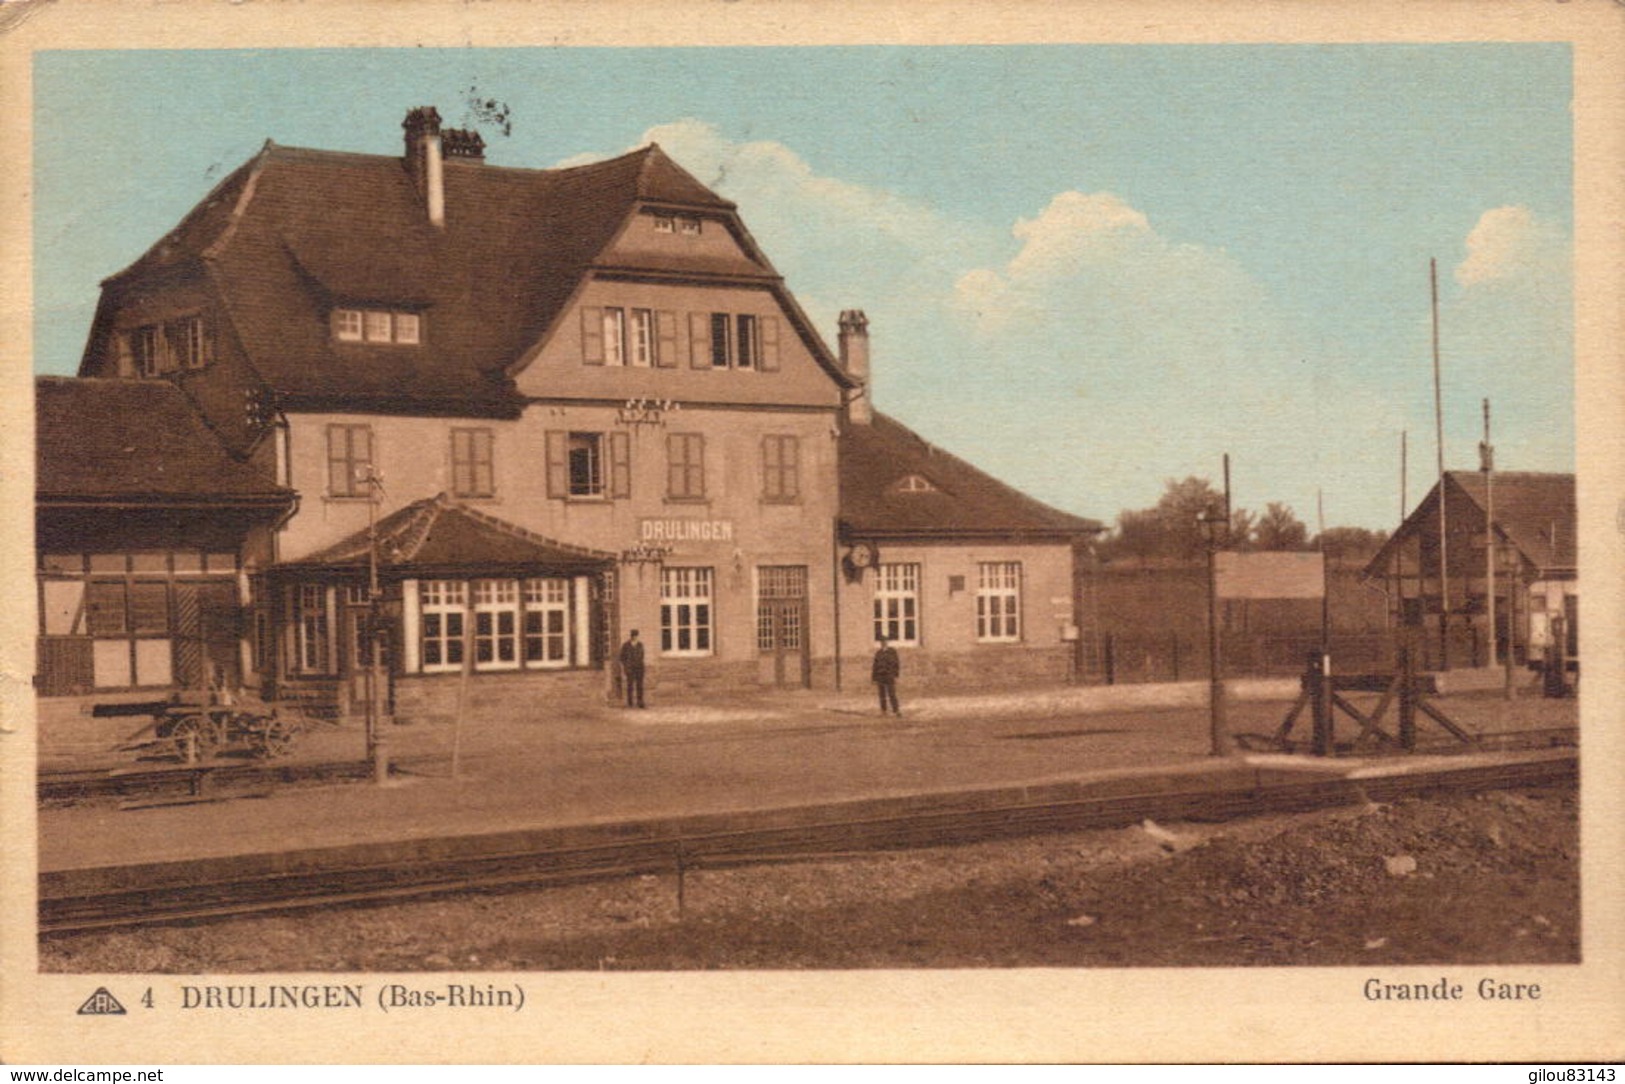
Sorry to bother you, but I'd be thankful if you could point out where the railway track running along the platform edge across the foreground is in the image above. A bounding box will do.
[39,752,1578,934]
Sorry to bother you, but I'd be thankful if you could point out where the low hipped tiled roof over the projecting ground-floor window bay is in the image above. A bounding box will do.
[281,492,614,575]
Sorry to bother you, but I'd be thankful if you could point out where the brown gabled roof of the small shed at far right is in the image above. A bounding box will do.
[1365,471,1580,575]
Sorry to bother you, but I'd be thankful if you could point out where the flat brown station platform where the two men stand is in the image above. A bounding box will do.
[39,683,1576,874]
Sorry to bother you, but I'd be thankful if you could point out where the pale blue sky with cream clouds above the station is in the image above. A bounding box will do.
[34,44,1575,528]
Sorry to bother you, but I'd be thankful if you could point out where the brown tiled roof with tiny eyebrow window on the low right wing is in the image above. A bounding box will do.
[840,414,1102,541]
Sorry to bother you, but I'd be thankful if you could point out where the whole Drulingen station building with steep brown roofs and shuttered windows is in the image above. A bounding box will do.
[39,109,1099,747]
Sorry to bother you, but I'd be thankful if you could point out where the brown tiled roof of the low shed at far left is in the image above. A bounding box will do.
[34,377,293,505]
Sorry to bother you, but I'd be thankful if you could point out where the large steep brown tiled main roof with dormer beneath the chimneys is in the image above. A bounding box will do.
[93,143,760,411]
